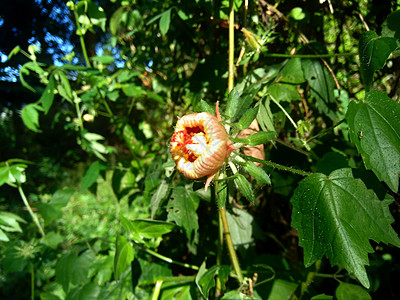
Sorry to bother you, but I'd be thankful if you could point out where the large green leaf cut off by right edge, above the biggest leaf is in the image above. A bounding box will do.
[346,90,400,192]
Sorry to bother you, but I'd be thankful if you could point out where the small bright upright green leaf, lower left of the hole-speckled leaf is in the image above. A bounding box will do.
[114,236,135,280]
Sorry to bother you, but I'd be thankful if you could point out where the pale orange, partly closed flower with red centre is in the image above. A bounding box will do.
[171,103,235,190]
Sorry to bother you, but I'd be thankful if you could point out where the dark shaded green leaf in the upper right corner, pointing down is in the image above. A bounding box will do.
[358,31,397,91]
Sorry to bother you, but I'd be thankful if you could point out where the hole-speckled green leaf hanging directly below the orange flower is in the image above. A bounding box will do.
[167,186,199,243]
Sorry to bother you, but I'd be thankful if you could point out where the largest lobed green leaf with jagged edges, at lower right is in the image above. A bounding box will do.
[291,168,400,288]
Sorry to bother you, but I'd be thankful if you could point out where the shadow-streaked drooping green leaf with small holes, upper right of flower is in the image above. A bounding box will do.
[302,59,337,121]
